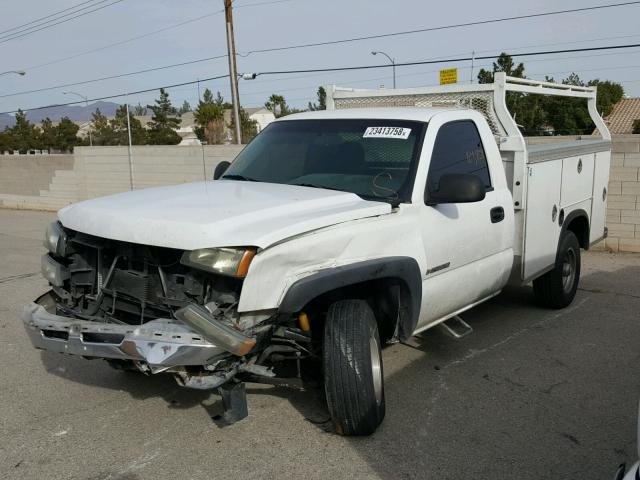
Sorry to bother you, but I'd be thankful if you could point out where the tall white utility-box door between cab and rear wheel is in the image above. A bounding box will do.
[524,160,562,278]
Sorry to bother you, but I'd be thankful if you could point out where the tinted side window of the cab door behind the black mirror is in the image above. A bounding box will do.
[427,120,491,195]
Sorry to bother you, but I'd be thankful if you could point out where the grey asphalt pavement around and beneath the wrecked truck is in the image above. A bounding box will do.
[0,210,640,480]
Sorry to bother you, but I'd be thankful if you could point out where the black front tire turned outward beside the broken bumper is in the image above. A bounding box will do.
[323,300,385,435]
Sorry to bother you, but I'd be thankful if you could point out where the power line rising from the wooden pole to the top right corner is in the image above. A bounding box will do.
[238,1,640,56]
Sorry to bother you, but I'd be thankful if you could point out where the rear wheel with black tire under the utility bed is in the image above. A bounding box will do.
[533,231,580,309]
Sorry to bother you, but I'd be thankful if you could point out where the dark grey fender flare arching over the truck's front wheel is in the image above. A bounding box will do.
[278,256,422,340]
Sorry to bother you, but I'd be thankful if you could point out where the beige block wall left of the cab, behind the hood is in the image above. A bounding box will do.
[0,145,243,211]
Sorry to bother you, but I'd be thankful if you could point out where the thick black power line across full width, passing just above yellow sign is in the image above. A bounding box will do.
[0,44,640,113]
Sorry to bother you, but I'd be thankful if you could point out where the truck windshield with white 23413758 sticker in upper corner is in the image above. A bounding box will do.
[222,119,426,203]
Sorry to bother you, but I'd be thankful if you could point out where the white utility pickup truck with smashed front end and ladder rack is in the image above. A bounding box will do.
[23,74,610,435]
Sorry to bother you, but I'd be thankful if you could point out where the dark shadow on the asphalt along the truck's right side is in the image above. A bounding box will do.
[322,267,640,480]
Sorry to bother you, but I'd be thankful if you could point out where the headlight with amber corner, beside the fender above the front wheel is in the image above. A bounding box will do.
[180,247,256,278]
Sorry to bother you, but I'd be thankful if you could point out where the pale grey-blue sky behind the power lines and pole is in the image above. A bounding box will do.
[0,0,640,112]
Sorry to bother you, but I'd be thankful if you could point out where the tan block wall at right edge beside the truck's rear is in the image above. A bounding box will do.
[605,135,640,252]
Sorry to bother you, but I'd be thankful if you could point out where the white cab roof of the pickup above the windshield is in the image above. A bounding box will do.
[277,107,459,122]
